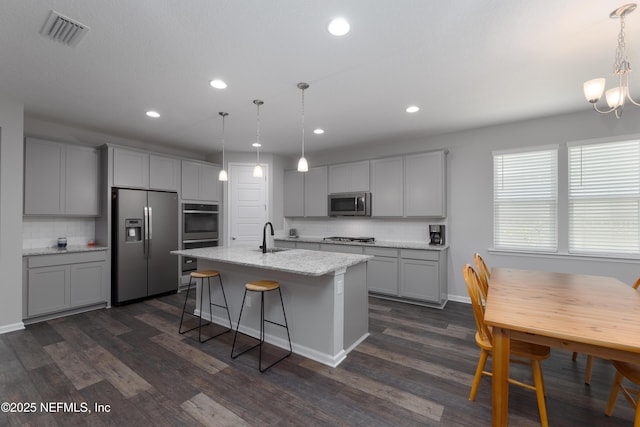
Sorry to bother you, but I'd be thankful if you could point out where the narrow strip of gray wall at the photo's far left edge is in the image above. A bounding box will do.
[0,101,24,333]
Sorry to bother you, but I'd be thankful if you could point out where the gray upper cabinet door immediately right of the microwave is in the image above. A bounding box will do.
[371,157,404,217]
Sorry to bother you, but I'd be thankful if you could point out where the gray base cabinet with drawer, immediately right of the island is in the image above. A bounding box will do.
[364,247,398,296]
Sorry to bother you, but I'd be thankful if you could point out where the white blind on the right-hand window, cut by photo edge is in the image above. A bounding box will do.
[569,140,640,254]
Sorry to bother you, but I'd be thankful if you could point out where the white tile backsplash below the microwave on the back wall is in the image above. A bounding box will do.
[284,218,444,242]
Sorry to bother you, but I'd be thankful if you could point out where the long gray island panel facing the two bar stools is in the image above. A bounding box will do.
[197,259,345,366]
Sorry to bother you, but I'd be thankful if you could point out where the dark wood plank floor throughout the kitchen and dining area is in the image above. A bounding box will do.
[0,293,634,426]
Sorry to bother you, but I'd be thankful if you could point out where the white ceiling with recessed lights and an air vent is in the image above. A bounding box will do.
[0,0,640,157]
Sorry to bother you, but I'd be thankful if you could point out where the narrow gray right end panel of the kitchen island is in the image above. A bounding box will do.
[344,262,369,353]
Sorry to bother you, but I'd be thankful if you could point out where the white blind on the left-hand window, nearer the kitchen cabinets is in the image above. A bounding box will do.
[493,148,558,252]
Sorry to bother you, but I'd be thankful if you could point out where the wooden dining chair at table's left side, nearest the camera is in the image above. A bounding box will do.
[463,264,551,427]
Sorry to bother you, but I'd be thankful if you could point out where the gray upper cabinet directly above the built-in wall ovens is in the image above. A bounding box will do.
[180,160,222,202]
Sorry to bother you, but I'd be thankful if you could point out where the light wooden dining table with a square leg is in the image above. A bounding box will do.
[485,268,640,426]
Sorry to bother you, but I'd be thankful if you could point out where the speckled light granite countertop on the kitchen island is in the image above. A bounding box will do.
[171,246,373,276]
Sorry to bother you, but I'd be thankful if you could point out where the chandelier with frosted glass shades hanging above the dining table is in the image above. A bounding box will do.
[584,3,640,119]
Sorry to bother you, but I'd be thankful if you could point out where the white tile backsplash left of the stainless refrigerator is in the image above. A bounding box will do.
[22,216,96,249]
